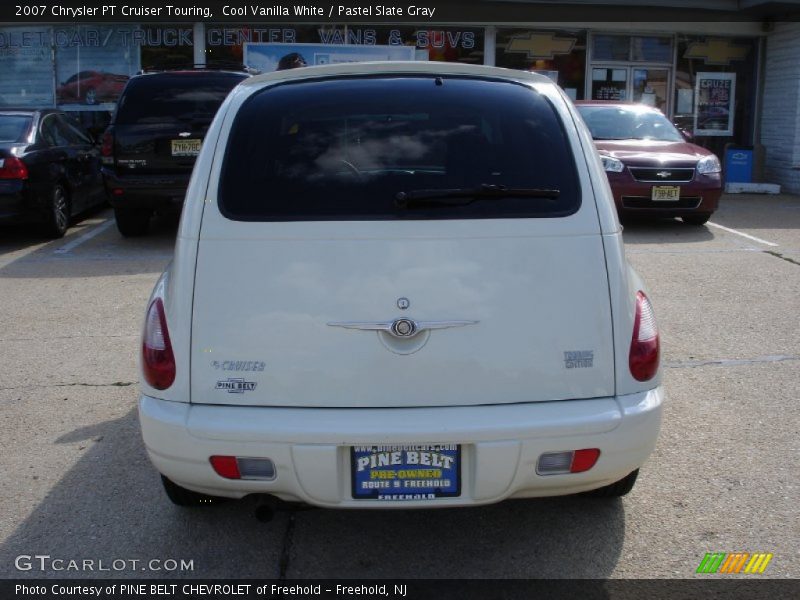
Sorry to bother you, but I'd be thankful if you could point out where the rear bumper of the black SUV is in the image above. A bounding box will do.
[102,167,191,210]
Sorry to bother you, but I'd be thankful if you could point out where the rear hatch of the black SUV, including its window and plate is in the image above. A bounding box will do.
[114,71,246,175]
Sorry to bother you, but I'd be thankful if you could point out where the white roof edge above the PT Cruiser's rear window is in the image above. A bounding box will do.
[240,61,555,88]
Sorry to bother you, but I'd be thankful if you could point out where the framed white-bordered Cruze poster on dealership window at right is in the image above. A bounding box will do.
[694,73,736,136]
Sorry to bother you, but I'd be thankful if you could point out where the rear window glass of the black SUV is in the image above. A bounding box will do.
[115,73,246,125]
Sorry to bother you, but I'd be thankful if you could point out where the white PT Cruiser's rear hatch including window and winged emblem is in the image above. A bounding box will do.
[191,77,614,407]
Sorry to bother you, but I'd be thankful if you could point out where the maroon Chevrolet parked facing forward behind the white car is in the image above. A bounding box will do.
[577,100,722,225]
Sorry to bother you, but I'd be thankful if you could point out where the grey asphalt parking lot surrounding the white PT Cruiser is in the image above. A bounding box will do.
[0,195,800,578]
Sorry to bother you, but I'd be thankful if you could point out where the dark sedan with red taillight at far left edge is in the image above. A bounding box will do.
[0,109,105,238]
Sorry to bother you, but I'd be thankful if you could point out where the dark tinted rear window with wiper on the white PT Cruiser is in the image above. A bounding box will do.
[219,77,580,221]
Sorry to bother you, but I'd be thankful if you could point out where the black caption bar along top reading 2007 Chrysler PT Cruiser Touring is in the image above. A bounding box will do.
[0,0,800,25]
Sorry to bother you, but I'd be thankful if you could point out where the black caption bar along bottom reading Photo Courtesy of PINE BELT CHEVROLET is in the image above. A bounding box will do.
[0,575,800,600]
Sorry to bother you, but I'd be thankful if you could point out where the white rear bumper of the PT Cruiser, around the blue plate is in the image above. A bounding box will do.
[139,387,664,508]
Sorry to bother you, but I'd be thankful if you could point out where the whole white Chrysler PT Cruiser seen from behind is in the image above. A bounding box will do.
[139,62,664,508]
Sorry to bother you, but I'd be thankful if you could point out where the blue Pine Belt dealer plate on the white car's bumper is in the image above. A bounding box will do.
[350,444,461,501]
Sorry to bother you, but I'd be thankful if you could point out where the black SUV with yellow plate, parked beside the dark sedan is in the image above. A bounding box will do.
[101,70,249,236]
